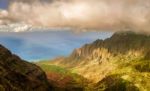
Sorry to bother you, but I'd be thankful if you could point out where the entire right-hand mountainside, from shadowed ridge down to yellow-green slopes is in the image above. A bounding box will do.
[40,32,150,91]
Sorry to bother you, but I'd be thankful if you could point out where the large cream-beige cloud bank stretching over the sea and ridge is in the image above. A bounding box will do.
[2,0,150,32]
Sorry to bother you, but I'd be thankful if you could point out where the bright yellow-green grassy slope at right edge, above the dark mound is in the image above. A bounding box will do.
[106,59,150,91]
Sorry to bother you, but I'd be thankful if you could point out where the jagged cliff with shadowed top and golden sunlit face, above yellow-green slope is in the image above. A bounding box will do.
[51,32,150,83]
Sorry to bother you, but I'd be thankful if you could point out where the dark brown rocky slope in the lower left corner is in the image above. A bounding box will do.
[0,45,52,91]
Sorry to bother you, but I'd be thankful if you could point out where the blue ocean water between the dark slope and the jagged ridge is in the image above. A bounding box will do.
[0,31,112,61]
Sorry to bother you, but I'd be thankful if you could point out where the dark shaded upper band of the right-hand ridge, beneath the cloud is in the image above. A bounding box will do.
[71,32,150,57]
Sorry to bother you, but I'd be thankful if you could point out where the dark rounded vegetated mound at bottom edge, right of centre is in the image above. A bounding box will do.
[96,75,138,91]
